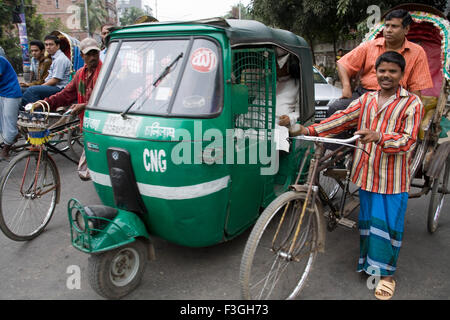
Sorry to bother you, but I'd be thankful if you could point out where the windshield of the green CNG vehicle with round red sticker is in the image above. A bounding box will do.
[91,37,223,117]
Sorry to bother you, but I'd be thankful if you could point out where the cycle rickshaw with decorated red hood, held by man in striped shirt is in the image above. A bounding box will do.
[240,4,450,299]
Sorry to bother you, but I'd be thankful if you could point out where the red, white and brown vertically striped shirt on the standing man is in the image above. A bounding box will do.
[308,87,423,194]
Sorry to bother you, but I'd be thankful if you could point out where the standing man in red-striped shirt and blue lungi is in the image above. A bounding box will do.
[290,51,423,300]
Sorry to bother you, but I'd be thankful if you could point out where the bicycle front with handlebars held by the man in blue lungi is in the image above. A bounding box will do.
[240,136,359,299]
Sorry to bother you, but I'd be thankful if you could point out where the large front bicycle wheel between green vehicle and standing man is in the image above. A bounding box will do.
[240,191,318,300]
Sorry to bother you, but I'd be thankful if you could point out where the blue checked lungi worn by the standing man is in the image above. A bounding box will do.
[357,189,408,276]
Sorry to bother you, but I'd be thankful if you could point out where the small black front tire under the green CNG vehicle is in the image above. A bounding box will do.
[88,239,148,299]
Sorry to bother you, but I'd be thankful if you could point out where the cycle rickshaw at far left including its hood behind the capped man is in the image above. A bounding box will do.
[0,30,84,241]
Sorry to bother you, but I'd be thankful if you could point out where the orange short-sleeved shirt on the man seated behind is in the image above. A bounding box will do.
[338,38,433,91]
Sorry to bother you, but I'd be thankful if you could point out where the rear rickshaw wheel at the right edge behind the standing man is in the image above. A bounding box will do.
[427,159,450,233]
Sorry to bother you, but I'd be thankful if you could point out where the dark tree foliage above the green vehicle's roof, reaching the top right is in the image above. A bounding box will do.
[251,0,447,62]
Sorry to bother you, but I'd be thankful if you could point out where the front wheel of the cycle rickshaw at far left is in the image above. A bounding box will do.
[0,151,60,241]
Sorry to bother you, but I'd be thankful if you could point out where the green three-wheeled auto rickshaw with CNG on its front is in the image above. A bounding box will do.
[68,18,314,298]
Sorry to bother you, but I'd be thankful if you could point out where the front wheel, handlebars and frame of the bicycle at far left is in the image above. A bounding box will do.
[0,102,79,241]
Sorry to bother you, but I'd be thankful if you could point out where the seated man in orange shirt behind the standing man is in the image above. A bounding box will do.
[327,9,433,117]
